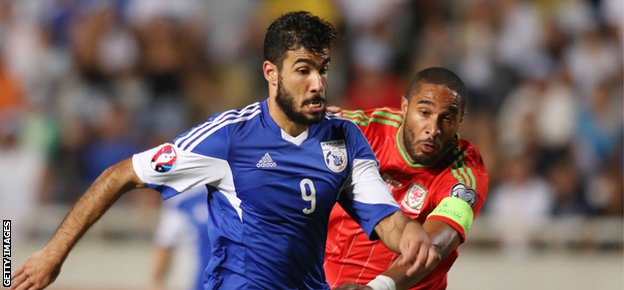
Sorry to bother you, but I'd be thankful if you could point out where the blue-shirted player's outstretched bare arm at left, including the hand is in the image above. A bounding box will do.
[11,159,144,290]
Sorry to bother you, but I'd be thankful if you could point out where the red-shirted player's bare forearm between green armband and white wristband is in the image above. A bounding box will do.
[382,220,461,289]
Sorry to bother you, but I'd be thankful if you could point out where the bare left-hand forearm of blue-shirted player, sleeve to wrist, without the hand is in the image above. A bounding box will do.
[45,159,142,261]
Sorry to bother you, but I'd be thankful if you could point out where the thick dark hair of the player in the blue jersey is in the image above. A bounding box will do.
[264,11,338,67]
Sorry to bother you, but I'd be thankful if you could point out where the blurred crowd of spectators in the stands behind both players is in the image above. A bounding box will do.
[0,0,624,249]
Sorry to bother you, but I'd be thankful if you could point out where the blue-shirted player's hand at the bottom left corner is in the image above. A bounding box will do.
[10,250,63,290]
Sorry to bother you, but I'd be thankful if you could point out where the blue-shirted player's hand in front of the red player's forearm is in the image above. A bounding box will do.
[397,220,432,276]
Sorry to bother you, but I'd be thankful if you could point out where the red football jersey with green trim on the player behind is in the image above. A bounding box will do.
[324,108,488,289]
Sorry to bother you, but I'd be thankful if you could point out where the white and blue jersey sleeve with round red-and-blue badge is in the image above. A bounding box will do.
[132,122,233,199]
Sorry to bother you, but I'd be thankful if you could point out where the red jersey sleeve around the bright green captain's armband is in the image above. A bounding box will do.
[427,144,488,242]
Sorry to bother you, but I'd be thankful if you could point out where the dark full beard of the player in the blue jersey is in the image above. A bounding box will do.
[275,76,325,126]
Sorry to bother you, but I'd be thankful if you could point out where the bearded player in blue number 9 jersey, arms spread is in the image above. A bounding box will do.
[11,12,436,290]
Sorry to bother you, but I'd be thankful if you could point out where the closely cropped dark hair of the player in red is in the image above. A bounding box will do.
[405,67,468,114]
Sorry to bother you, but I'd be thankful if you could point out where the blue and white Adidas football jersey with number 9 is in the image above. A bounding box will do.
[133,101,400,289]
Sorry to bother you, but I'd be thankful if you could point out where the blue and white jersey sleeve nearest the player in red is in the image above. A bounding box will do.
[338,120,400,240]
